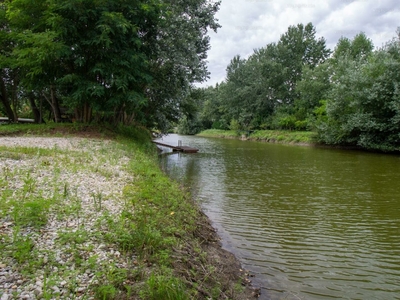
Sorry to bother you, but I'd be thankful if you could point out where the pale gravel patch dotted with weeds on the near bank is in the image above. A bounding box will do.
[0,137,135,300]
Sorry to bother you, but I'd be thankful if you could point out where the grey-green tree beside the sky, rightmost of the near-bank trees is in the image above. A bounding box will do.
[141,0,220,131]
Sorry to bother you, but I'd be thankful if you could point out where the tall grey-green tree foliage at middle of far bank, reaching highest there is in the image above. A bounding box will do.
[192,23,330,135]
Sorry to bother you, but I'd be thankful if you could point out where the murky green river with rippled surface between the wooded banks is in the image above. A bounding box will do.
[160,134,400,300]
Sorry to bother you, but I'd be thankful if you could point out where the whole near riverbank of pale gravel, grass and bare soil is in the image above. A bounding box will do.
[0,125,257,300]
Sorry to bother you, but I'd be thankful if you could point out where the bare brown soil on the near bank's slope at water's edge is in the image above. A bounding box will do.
[174,211,260,300]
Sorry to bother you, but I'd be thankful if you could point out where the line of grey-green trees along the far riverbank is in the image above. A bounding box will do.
[179,23,400,151]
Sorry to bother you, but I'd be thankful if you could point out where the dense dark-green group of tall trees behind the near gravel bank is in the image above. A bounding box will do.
[0,0,219,130]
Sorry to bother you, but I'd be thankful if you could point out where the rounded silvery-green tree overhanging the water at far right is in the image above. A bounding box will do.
[319,41,400,151]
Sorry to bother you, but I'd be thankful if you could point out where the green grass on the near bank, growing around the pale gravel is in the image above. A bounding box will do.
[0,125,255,299]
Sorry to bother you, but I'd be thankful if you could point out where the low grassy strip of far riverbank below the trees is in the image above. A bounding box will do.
[197,129,315,145]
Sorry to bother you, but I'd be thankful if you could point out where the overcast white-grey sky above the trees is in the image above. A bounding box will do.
[201,0,400,86]
